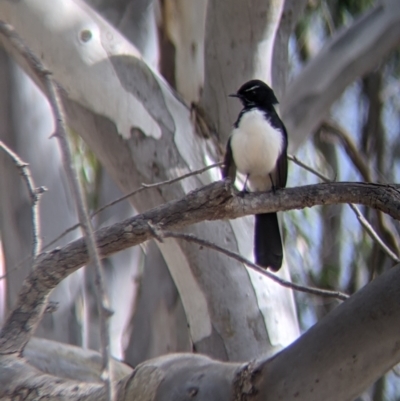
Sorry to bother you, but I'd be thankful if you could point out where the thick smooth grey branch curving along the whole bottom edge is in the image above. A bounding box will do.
[0,267,400,401]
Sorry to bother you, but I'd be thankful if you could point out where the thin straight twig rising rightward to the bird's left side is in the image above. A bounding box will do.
[41,162,223,250]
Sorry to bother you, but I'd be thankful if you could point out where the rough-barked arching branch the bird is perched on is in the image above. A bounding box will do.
[0,181,400,353]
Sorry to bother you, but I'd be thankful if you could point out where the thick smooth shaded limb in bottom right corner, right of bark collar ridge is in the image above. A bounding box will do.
[253,266,400,401]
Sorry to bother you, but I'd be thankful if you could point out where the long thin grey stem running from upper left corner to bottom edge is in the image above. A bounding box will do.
[0,22,114,401]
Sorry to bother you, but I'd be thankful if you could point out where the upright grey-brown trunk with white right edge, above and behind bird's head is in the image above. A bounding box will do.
[201,0,284,145]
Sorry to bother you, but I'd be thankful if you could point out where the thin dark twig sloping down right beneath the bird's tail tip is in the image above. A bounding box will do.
[161,229,349,301]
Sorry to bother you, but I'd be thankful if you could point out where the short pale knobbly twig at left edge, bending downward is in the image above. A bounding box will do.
[0,141,46,261]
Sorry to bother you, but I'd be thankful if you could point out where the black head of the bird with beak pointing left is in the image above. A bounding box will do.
[229,79,278,108]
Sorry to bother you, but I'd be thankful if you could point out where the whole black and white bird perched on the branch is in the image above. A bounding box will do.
[222,80,288,271]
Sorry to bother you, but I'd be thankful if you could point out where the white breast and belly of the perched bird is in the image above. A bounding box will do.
[231,109,283,190]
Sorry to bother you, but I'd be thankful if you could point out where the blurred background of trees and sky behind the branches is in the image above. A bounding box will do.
[0,0,400,401]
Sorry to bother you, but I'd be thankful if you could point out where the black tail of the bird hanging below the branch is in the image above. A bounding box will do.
[254,213,283,271]
